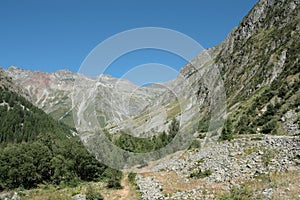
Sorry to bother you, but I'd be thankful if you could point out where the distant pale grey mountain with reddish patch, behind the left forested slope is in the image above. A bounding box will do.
[6,66,169,133]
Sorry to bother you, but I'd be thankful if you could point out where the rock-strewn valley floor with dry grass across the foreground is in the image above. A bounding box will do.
[1,135,300,200]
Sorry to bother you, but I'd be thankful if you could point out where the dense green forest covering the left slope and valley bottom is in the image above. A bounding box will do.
[0,87,122,191]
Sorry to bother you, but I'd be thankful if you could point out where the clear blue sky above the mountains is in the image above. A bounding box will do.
[0,0,257,83]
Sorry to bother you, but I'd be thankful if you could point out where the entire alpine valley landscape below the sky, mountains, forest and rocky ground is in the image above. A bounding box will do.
[0,0,300,200]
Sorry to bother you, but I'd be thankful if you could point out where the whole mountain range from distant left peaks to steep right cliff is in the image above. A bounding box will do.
[7,1,299,141]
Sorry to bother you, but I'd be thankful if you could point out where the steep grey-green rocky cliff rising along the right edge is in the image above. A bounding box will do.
[214,0,300,134]
